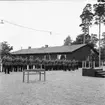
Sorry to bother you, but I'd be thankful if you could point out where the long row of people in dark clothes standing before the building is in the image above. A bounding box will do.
[3,55,79,74]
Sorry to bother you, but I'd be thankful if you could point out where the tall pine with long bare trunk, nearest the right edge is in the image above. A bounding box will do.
[93,3,105,67]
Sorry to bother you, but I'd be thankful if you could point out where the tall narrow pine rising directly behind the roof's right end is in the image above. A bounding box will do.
[80,4,94,43]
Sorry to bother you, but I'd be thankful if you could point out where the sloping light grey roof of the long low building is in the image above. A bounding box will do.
[12,44,86,54]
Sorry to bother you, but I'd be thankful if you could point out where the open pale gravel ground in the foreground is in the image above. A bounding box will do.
[0,69,105,105]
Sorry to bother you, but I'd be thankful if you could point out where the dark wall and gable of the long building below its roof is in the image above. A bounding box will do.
[13,46,98,61]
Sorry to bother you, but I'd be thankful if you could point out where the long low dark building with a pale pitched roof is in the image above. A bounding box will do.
[12,44,98,61]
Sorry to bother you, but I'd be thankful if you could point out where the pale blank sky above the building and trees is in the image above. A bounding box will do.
[0,0,101,51]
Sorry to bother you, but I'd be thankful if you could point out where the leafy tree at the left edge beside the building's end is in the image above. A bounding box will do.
[0,41,13,59]
